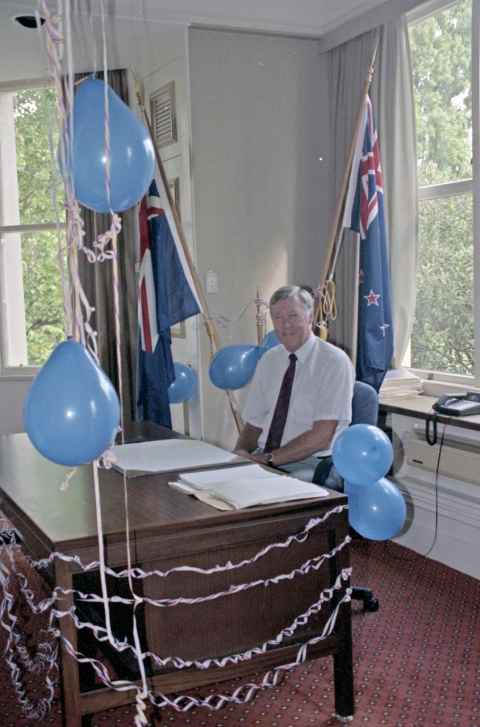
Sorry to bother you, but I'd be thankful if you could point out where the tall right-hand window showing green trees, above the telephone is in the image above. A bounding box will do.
[409,0,479,376]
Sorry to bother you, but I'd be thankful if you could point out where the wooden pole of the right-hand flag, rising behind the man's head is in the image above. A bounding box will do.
[314,33,379,336]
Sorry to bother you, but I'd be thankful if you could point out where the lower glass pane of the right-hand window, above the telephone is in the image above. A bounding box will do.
[411,194,474,375]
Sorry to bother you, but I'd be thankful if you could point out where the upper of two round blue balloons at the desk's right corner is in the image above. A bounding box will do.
[332,424,393,485]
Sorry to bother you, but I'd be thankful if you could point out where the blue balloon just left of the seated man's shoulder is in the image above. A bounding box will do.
[209,345,261,389]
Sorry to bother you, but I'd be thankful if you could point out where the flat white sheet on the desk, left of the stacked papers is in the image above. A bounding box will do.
[112,439,238,472]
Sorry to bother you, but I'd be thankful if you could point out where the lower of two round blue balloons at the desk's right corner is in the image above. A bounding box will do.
[348,477,407,540]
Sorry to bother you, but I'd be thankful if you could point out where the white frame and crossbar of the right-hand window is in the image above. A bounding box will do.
[405,0,480,388]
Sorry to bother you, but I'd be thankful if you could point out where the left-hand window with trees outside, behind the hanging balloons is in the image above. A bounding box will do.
[0,84,64,373]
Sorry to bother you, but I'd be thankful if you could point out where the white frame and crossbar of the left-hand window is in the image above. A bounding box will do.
[0,78,66,381]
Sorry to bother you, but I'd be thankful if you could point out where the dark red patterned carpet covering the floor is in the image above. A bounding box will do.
[0,516,480,727]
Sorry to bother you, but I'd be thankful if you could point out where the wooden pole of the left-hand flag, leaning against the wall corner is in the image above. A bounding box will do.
[135,82,242,433]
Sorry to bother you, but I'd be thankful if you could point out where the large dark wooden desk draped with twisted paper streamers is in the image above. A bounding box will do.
[0,434,354,727]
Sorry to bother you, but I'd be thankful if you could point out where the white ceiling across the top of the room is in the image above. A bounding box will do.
[0,0,394,83]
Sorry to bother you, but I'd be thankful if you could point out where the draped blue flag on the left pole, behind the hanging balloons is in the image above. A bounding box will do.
[137,179,201,427]
